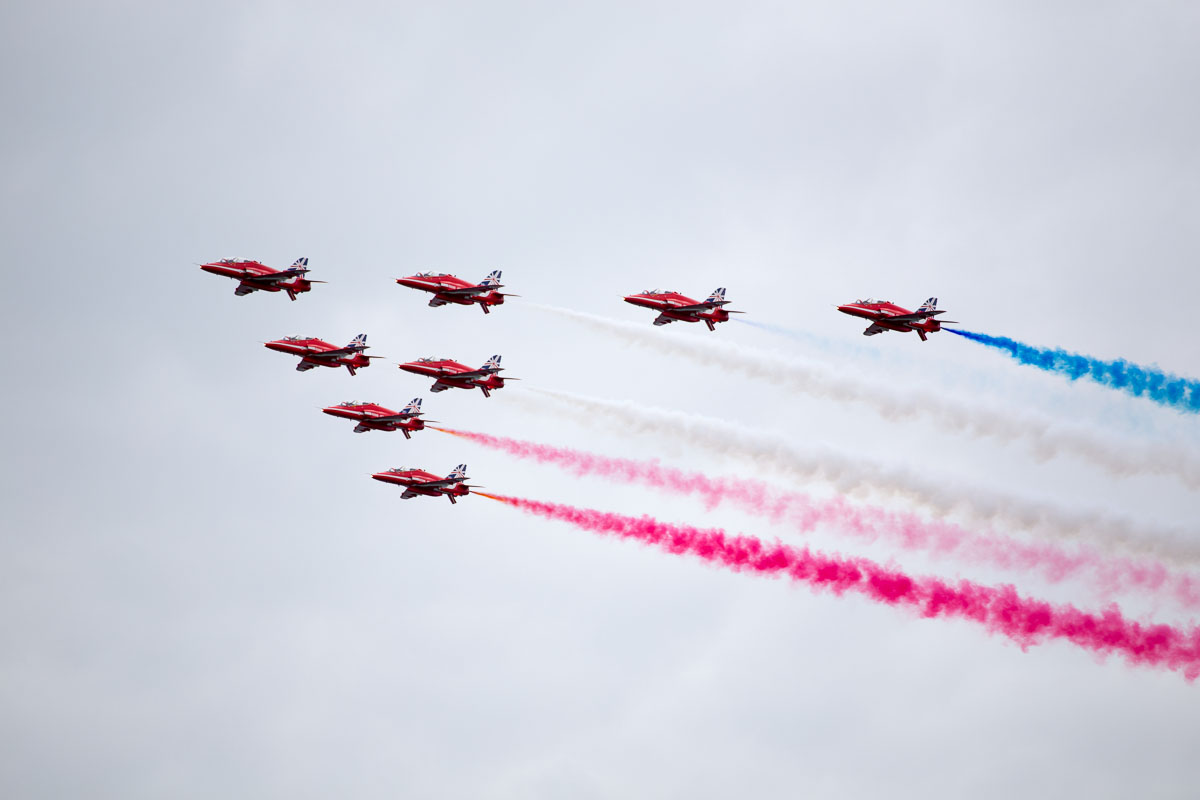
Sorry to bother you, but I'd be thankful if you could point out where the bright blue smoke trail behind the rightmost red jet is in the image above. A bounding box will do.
[942,327,1200,414]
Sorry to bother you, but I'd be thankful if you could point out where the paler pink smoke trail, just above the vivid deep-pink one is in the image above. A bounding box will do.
[428,426,1200,608]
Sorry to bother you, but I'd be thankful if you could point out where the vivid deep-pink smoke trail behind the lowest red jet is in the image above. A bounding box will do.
[492,495,1200,681]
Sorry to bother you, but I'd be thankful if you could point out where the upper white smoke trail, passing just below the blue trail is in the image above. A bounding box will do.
[527,303,1200,489]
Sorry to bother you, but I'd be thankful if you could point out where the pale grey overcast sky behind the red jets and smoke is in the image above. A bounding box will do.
[0,1,1200,799]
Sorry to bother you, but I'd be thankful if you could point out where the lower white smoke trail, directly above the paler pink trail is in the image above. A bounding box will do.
[509,389,1200,567]
